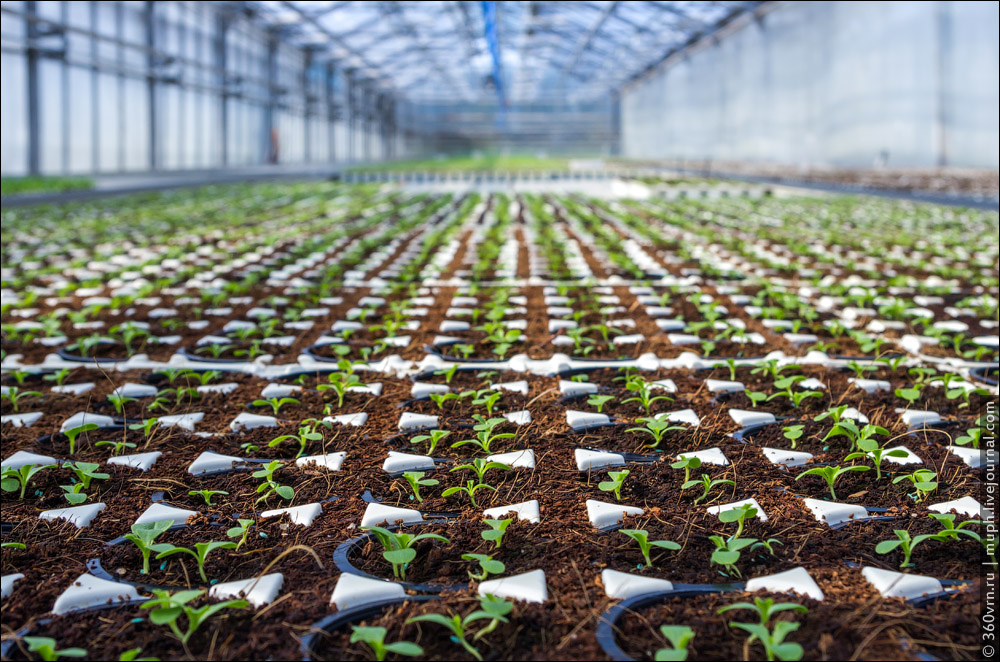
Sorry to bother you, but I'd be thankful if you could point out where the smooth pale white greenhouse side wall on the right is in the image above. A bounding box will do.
[621,1,1000,168]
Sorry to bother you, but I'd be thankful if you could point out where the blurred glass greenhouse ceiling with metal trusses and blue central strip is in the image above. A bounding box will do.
[254,0,761,105]
